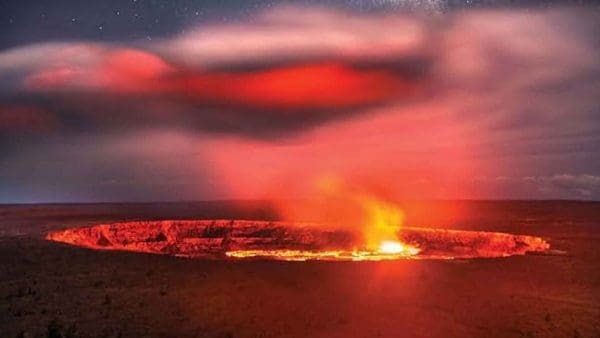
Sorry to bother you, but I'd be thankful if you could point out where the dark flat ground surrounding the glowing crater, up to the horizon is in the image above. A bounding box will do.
[0,201,600,337]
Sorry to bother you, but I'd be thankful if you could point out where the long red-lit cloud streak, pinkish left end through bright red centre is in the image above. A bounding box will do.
[25,49,420,110]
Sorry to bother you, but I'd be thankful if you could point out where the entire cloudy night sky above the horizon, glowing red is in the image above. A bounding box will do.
[0,0,600,203]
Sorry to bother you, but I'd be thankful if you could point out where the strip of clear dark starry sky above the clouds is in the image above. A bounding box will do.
[0,0,598,49]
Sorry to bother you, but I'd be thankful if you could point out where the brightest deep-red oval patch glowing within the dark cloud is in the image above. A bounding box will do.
[176,62,417,109]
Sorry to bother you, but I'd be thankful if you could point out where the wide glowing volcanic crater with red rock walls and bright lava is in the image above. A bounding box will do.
[47,220,550,261]
